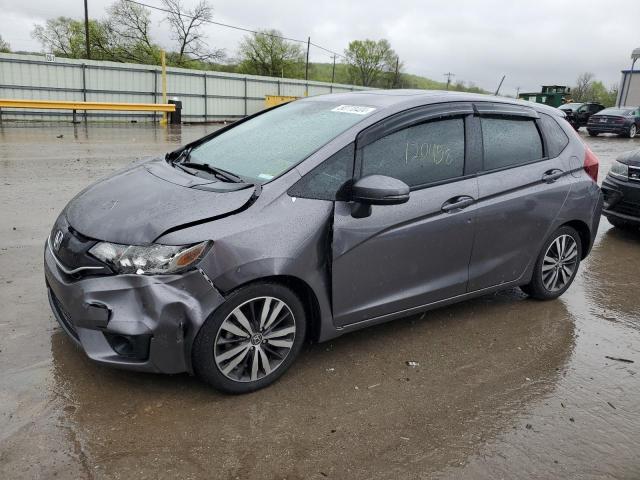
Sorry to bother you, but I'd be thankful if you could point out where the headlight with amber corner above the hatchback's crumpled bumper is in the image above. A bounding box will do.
[89,242,211,275]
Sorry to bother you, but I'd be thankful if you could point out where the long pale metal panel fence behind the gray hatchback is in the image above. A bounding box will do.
[0,54,364,122]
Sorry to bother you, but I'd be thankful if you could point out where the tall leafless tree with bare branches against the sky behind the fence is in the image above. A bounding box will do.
[162,0,224,65]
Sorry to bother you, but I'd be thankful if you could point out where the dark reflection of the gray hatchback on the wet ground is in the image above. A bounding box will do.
[51,289,575,478]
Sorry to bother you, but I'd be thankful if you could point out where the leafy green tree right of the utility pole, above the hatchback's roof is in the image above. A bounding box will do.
[344,39,398,87]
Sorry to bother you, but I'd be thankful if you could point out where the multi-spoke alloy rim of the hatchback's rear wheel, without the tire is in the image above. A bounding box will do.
[542,234,578,292]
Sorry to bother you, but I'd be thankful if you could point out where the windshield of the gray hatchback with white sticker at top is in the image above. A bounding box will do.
[189,101,375,183]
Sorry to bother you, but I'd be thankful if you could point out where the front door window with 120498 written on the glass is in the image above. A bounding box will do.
[362,118,464,187]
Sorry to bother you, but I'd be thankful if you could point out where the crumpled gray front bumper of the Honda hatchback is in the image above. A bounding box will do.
[44,242,224,373]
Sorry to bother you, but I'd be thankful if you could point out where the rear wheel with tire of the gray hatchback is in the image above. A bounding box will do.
[521,226,582,300]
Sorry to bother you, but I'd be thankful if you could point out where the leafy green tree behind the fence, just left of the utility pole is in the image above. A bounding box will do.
[239,30,304,78]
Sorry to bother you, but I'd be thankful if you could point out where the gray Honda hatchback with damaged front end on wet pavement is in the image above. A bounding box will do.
[44,90,602,393]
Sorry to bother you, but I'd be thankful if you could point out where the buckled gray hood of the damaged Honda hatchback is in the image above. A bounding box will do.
[65,159,255,245]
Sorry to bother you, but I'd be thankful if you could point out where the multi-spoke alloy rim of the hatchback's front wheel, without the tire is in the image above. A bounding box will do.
[213,297,296,382]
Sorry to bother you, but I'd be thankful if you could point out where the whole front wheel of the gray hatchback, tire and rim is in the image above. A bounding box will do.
[192,282,307,394]
